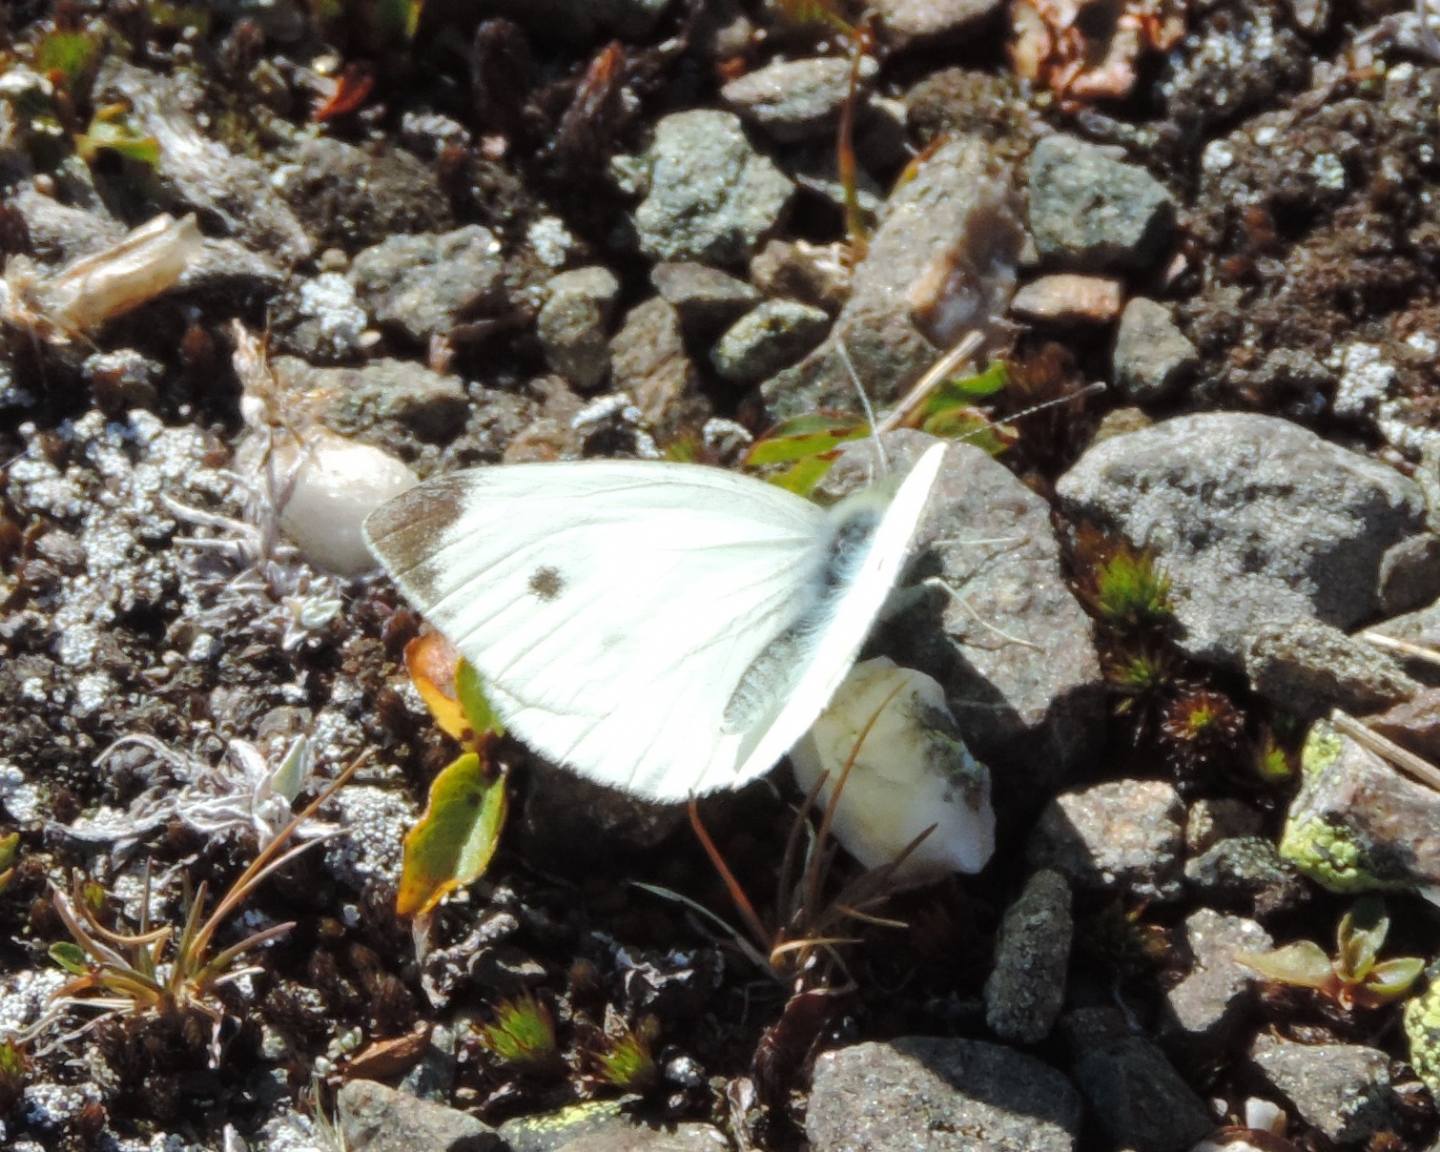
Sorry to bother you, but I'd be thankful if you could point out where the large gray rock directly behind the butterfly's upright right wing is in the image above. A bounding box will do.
[819,432,1106,812]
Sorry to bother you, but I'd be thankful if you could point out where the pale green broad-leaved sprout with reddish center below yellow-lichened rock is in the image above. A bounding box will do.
[1236,897,1426,1011]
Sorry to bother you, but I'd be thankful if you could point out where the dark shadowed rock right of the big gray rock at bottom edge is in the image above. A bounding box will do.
[1064,1008,1214,1152]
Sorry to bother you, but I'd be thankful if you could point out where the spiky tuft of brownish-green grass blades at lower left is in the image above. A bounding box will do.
[27,756,366,1066]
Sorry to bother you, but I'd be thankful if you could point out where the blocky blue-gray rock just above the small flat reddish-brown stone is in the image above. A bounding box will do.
[1027,135,1175,272]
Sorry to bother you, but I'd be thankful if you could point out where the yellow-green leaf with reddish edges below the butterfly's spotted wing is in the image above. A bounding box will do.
[395,752,508,916]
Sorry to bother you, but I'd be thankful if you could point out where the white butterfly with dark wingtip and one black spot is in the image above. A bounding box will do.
[366,445,945,801]
